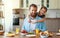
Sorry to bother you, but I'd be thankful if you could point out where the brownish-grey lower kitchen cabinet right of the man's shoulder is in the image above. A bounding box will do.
[46,18,60,32]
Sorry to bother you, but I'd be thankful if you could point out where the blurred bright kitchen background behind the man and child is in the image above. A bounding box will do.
[0,0,60,32]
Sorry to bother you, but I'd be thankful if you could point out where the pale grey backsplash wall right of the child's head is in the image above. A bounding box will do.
[46,9,60,18]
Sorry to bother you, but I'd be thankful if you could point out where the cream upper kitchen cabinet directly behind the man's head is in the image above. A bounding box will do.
[23,0,41,8]
